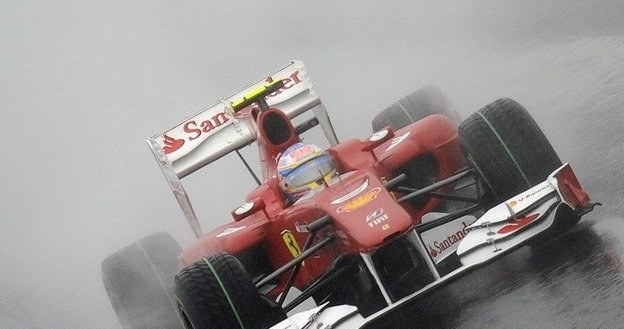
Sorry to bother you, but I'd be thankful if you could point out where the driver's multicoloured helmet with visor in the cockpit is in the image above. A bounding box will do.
[277,143,336,202]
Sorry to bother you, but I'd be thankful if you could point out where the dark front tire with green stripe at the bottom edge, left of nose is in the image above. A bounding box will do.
[174,253,286,329]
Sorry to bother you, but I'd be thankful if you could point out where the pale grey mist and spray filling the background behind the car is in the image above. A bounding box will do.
[0,0,624,328]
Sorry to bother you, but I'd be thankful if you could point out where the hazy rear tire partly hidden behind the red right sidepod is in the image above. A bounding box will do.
[372,86,459,132]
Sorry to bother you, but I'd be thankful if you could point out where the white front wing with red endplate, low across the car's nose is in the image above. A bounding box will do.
[272,164,595,328]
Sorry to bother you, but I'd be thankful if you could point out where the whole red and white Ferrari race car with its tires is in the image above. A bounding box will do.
[102,61,594,329]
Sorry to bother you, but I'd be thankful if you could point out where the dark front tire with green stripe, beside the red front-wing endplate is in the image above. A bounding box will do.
[459,98,561,203]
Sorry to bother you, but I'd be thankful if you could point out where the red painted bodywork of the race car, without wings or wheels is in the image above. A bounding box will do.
[180,109,464,297]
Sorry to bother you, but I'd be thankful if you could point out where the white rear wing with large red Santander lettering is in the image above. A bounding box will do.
[147,61,338,237]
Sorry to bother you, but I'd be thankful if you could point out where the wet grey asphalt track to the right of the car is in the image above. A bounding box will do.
[376,37,624,329]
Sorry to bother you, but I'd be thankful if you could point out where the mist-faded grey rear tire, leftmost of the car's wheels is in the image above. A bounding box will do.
[102,232,184,329]
